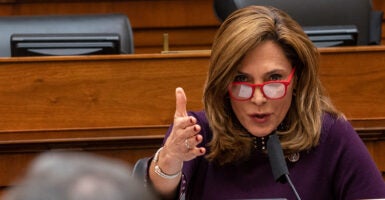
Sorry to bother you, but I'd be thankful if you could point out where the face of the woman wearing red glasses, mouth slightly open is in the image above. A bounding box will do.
[230,41,294,137]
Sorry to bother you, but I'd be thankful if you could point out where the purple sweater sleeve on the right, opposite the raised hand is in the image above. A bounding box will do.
[327,116,385,199]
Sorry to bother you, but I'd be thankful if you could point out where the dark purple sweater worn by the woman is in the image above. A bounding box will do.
[161,112,385,200]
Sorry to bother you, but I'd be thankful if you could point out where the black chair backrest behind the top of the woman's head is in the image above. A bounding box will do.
[214,0,382,45]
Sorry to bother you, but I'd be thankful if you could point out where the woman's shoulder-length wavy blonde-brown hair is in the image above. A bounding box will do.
[203,6,343,165]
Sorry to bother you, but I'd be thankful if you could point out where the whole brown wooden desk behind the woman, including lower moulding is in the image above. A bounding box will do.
[0,46,385,193]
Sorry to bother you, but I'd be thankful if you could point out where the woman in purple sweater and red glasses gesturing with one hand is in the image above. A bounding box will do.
[149,6,385,200]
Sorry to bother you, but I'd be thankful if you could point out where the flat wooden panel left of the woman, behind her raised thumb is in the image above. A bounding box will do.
[0,54,208,130]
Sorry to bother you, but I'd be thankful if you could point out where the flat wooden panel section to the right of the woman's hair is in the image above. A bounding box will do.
[320,46,385,119]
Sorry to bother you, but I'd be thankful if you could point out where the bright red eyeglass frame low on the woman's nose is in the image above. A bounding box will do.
[228,67,295,101]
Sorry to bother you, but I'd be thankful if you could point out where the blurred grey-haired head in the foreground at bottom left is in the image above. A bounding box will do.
[4,152,155,200]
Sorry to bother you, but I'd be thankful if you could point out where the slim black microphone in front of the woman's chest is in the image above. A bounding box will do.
[267,131,301,200]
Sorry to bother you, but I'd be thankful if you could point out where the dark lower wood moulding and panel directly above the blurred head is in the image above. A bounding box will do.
[0,126,167,188]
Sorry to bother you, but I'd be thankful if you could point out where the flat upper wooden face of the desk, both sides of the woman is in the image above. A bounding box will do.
[0,46,385,131]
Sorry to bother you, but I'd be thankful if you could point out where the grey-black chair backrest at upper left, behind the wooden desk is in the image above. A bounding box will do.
[0,14,134,57]
